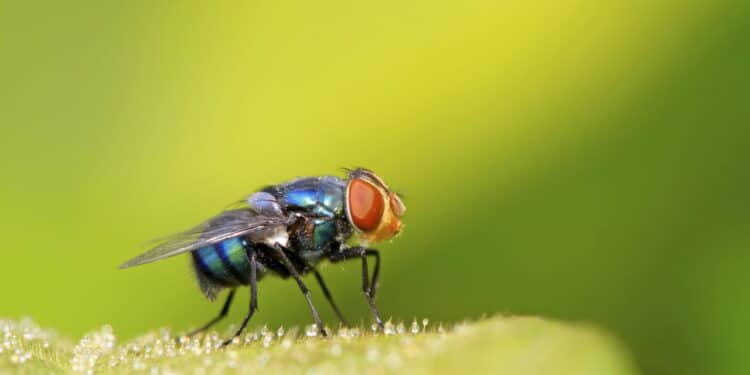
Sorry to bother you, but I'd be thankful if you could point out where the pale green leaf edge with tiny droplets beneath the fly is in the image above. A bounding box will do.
[0,316,637,375]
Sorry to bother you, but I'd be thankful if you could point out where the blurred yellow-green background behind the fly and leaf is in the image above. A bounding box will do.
[0,1,750,374]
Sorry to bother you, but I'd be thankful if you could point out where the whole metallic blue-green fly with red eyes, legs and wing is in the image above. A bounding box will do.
[120,168,406,345]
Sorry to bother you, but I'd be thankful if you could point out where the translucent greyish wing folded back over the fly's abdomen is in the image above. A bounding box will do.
[120,208,288,269]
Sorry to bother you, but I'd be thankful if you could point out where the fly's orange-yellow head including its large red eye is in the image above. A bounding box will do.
[345,168,406,243]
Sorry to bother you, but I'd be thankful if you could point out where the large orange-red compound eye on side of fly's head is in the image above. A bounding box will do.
[348,178,385,232]
